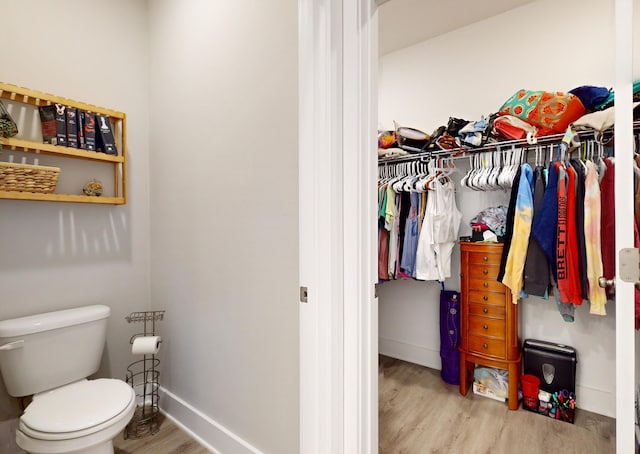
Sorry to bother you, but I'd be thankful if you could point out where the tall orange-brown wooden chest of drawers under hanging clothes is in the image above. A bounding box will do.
[460,243,522,410]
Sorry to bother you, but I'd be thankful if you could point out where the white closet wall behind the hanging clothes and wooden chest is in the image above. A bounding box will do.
[379,0,628,416]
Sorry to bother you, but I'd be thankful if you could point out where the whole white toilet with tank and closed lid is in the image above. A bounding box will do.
[0,305,136,454]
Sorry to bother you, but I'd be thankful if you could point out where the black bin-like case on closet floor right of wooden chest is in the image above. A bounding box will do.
[523,339,578,393]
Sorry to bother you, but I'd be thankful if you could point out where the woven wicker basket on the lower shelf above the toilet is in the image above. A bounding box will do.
[0,162,60,194]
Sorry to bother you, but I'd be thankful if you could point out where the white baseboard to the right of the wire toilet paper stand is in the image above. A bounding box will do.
[160,386,262,454]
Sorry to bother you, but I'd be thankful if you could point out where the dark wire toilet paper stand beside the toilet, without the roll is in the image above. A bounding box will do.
[124,311,165,439]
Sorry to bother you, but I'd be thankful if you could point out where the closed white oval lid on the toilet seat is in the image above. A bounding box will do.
[20,378,134,433]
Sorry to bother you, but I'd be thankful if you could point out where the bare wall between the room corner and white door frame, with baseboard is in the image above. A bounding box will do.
[149,0,299,453]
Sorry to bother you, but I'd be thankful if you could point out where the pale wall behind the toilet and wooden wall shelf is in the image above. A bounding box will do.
[0,0,149,452]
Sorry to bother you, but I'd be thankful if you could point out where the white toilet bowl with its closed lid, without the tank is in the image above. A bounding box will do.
[16,378,136,454]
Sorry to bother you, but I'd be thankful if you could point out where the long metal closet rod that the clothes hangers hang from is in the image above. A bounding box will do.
[378,121,640,165]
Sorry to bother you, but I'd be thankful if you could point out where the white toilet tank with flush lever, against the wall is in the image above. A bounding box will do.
[0,305,111,397]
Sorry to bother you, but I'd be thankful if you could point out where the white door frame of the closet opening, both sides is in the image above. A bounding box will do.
[298,0,636,454]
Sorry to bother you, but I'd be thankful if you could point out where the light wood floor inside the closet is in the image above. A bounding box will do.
[379,356,615,454]
